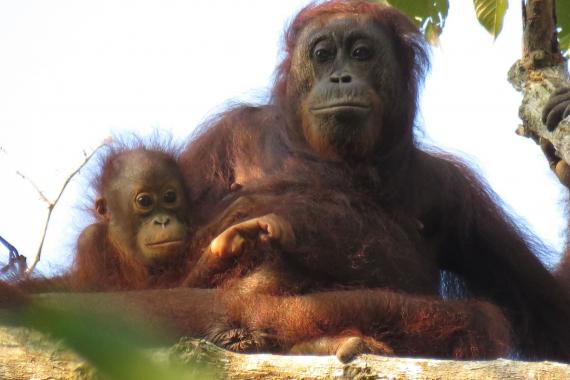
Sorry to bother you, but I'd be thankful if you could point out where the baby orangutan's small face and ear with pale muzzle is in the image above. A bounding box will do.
[97,151,188,264]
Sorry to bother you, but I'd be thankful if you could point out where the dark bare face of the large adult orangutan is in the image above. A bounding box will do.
[289,15,405,160]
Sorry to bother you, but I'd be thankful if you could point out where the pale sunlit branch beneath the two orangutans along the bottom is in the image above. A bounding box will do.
[0,328,570,380]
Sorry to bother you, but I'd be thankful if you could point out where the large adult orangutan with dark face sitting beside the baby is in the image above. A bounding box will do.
[181,0,570,360]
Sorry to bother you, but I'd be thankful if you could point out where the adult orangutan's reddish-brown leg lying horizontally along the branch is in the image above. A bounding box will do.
[224,289,510,359]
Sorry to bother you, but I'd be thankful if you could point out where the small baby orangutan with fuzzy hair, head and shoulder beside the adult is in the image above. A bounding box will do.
[69,147,190,290]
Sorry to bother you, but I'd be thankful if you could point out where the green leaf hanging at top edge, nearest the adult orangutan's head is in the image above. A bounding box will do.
[387,0,449,44]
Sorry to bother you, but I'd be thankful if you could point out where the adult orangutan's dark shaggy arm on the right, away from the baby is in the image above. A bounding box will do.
[430,152,570,360]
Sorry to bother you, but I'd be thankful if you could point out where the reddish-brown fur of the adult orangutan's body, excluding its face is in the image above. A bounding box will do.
[181,0,570,360]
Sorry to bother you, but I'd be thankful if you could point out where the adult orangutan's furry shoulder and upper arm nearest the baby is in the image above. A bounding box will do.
[179,105,283,224]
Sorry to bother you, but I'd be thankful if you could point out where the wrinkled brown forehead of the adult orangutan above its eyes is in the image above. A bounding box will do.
[297,14,388,48]
